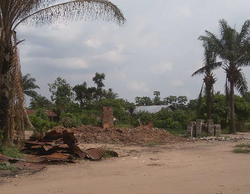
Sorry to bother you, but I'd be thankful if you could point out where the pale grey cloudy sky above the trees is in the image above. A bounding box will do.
[17,0,250,102]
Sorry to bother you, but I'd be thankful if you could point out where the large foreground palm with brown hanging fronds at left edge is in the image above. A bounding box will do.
[0,0,125,142]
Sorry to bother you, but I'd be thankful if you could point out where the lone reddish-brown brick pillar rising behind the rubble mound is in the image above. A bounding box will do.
[102,107,114,129]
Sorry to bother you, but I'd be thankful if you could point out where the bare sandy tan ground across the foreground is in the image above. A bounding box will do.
[0,134,250,194]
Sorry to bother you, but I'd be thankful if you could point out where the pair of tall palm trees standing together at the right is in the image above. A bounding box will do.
[192,19,250,133]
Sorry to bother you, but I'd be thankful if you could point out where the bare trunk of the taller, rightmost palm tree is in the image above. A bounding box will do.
[229,81,236,134]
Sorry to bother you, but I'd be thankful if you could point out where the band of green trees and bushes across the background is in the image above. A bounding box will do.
[23,72,250,136]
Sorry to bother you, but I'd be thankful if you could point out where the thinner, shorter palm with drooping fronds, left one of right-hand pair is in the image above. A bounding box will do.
[192,44,216,119]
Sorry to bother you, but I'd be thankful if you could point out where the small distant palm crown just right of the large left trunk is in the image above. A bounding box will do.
[22,73,40,98]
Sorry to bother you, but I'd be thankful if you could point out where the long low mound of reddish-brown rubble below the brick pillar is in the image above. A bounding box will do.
[72,126,183,144]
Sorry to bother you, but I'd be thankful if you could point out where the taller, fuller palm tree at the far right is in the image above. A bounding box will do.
[199,19,250,133]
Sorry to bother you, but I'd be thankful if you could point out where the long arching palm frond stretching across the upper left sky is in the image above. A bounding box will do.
[14,0,126,29]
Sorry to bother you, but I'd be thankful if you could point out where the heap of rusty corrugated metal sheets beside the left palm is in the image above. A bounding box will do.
[23,127,113,163]
